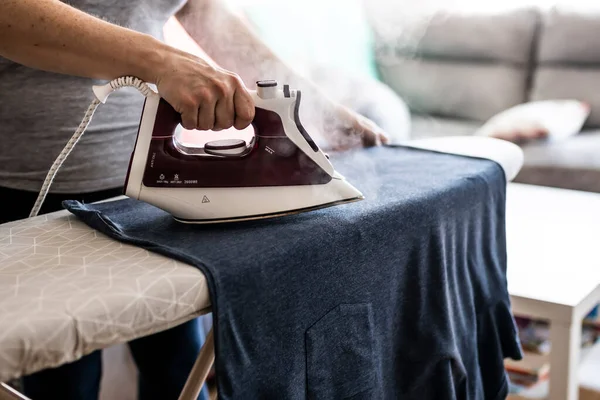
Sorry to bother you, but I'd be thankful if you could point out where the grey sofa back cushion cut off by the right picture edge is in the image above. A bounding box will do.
[531,3,600,128]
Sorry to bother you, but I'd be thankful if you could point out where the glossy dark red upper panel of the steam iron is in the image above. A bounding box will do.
[128,99,331,188]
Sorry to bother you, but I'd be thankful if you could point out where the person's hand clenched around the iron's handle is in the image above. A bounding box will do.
[155,49,254,131]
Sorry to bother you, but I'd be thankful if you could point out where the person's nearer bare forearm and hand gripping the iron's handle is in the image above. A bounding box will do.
[0,0,254,129]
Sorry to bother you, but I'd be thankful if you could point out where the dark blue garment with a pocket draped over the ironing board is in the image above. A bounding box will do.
[65,147,521,400]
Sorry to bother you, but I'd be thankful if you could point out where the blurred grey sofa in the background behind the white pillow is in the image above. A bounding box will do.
[374,5,600,192]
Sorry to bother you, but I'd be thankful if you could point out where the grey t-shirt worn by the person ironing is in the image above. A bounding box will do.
[0,0,185,193]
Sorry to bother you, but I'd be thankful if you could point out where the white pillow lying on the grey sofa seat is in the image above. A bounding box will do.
[475,99,590,140]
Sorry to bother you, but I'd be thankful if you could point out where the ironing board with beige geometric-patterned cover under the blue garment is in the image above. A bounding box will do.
[0,137,523,400]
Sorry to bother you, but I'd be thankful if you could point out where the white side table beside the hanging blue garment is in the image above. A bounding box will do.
[507,183,600,400]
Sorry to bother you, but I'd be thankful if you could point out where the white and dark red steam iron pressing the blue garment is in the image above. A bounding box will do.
[125,81,363,223]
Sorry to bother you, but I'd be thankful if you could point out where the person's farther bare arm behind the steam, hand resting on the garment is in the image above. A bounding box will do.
[176,0,387,148]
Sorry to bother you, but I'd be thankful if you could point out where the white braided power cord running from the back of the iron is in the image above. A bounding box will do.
[29,76,154,218]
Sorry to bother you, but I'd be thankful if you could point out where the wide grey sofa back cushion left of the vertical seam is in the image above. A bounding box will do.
[376,7,539,122]
